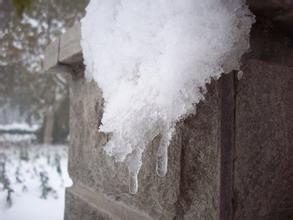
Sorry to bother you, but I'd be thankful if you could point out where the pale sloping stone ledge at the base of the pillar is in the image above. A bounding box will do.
[65,184,151,220]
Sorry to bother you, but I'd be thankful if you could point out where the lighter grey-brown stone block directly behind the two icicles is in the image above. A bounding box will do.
[69,79,180,218]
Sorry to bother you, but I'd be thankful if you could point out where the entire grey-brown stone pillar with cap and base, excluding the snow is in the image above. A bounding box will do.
[45,0,293,220]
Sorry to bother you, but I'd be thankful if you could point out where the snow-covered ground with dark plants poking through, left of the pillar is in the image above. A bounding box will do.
[0,141,72,220]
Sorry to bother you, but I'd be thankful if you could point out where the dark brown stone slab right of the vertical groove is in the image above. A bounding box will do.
[234,60,293,219]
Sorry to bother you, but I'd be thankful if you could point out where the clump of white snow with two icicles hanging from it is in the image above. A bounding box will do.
[81,0,254,193]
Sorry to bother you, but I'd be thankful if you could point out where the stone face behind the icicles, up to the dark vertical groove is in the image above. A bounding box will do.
[69,72,224,219]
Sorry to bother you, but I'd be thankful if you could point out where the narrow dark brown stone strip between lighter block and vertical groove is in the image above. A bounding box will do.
[176,78,221,220]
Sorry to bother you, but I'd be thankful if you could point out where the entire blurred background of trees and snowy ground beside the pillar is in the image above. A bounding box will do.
[0,0,88,220]
